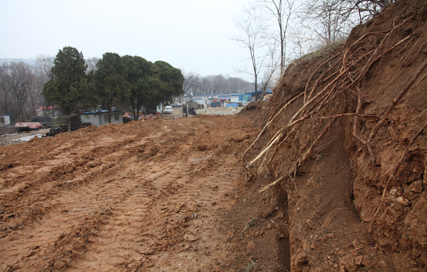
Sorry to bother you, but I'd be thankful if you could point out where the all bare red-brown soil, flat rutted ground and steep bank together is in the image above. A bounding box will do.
[0,0,427,271]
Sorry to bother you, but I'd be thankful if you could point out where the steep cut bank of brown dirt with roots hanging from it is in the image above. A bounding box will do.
[244,0,427,271]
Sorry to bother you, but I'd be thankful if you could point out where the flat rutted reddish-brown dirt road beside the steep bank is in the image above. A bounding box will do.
[0,111,288,271]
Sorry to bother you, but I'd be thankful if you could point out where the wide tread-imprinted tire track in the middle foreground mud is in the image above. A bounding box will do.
[70,153,239,271]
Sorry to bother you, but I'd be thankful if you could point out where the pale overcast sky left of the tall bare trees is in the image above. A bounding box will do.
[0,0,249,79]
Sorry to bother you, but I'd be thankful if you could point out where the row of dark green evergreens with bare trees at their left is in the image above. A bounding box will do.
[0,47,184,130]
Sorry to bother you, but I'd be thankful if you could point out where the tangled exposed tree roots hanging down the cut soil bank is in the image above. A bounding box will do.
[242,10,427,223]
